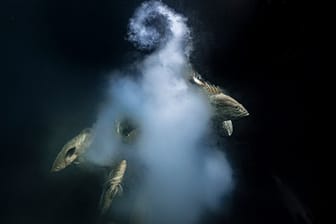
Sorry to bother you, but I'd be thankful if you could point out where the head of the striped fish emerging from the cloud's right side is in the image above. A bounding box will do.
[210,93,249,120]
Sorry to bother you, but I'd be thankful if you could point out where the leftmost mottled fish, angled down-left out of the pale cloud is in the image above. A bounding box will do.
[51,128,93,172]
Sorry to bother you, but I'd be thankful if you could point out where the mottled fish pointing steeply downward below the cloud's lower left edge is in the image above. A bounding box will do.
[100,160,127,214]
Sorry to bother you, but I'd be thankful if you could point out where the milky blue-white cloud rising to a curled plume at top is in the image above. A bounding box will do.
[87,1,233,224]
